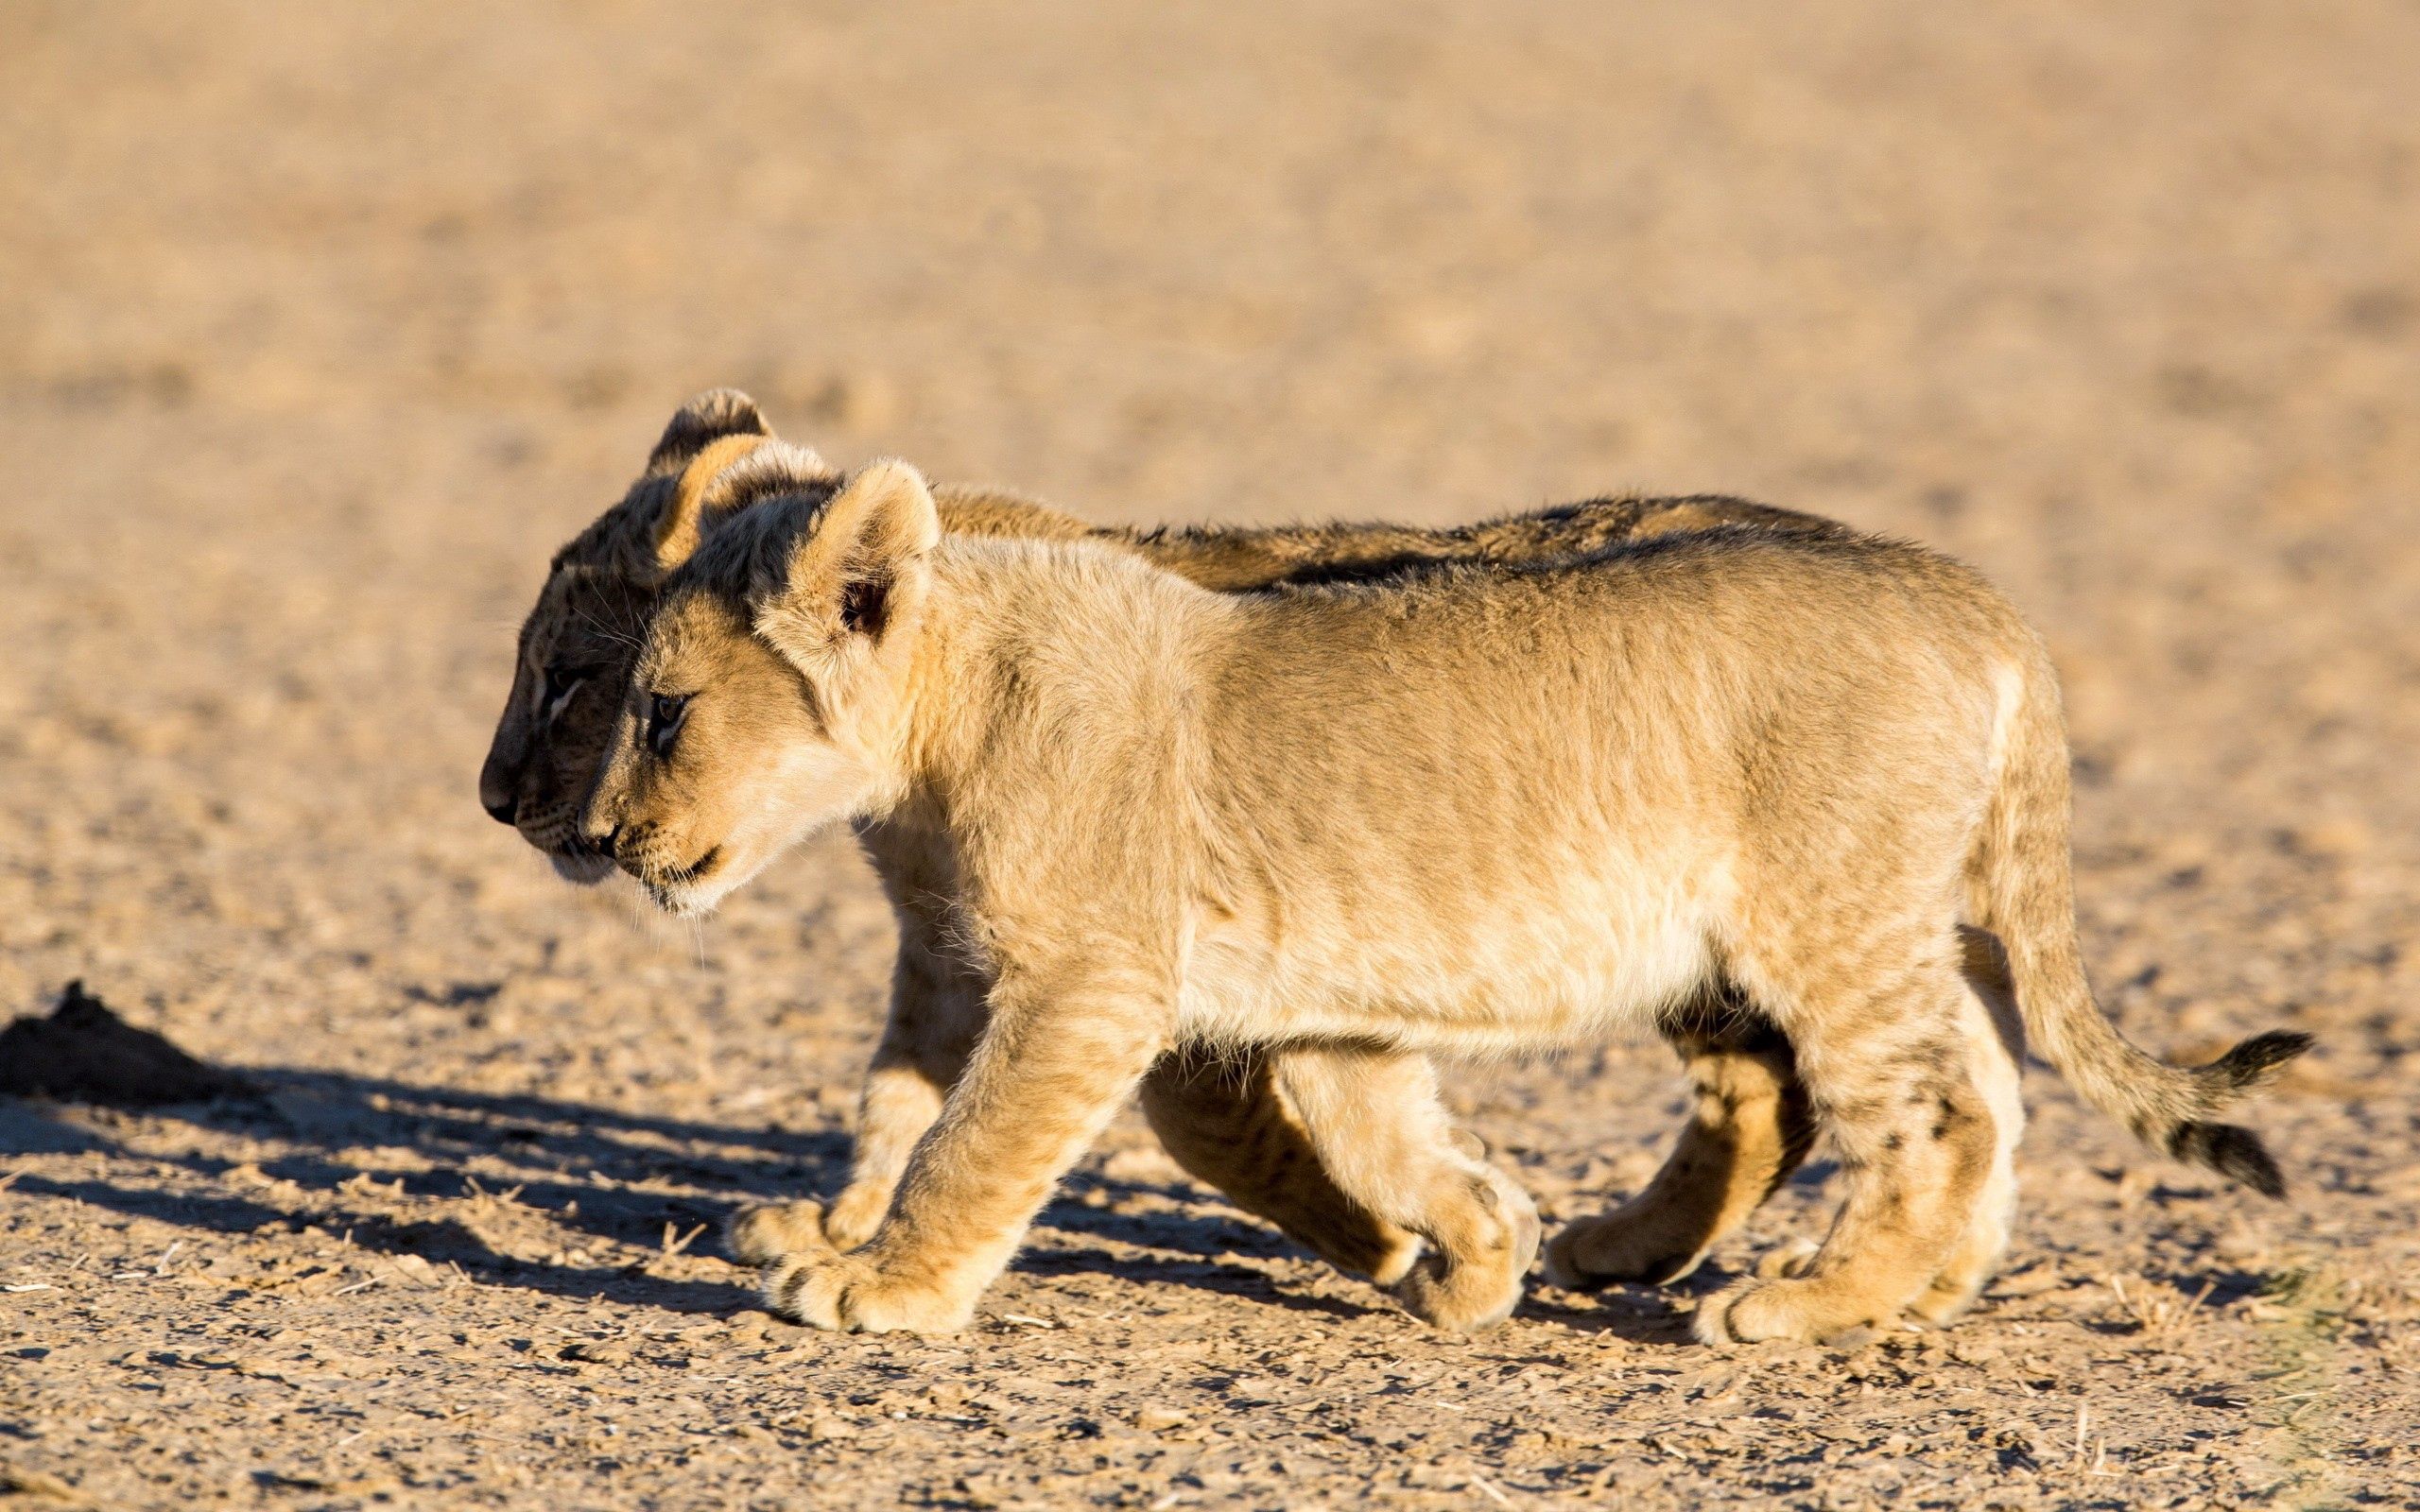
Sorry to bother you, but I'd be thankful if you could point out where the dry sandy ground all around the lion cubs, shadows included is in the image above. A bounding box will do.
[0,0,2420,1509]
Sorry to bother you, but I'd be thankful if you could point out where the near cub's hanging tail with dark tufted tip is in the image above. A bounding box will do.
[1967,636,2311,1197]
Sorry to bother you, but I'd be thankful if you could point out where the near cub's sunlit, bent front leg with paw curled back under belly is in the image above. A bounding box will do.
[1270,1045,1539,1331]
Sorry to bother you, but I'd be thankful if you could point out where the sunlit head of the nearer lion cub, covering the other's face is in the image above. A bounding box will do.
[580,455,942,915]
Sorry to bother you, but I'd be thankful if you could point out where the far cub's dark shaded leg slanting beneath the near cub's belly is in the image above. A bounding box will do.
[1142,1047,1421,1287]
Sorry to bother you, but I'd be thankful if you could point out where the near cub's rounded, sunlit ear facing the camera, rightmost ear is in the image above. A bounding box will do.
[755,459,942,673]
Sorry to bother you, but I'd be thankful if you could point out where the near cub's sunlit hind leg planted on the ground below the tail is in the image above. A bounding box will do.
[1697,929,2006,1343]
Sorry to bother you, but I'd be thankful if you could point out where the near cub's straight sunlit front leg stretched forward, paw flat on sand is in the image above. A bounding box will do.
[765,965,1176,1333]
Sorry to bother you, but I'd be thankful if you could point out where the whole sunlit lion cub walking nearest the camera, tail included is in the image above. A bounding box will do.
[580,445,2307,1340]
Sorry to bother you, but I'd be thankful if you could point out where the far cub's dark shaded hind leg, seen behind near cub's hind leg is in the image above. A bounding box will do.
[1547,1004,1815,1289]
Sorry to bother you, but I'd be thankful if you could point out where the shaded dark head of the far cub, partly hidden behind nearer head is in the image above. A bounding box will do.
[479,389,837,883]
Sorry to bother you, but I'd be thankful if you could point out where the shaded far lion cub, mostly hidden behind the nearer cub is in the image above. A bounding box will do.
[481,389,1945,1315]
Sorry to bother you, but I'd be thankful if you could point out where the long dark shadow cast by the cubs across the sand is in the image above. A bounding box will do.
[0,1050,1423,1318]
